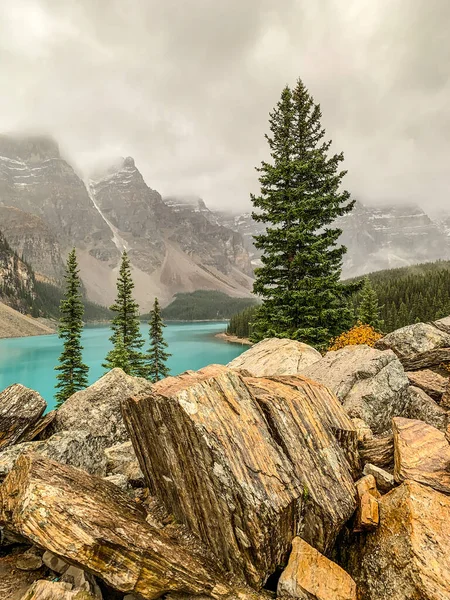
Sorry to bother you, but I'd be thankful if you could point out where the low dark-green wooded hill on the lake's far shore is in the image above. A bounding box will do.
[148,290,256,321]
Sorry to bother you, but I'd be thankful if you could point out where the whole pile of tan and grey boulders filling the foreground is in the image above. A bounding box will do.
[0,318,450,600]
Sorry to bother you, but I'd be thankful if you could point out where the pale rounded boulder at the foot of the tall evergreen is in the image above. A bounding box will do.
[228,338,322,377]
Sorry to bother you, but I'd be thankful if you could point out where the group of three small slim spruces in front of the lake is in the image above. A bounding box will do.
[55,248,170,406]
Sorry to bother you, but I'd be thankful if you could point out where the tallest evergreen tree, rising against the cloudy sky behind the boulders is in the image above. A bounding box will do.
[252,80,360,346]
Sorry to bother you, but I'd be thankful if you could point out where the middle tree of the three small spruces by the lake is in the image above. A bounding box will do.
[103,252,146,377]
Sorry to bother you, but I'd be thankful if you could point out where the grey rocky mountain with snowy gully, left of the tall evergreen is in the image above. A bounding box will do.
[0,136,252,309]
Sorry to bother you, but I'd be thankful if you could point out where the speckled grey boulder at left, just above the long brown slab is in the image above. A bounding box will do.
[0,430,107,480]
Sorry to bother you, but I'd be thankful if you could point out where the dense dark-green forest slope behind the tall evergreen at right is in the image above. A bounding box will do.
[227,260,450,338]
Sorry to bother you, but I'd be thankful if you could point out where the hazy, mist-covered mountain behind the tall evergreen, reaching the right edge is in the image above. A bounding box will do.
[215,202,450,277]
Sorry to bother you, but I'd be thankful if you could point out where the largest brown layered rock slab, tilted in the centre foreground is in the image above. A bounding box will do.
[123,365,356,586]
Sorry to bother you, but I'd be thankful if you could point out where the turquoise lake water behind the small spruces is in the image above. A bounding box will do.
[0,322,247,408]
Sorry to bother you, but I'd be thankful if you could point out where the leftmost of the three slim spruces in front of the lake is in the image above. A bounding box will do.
[55,248,89,406]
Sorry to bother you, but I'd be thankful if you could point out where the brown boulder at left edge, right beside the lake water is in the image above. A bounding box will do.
[0,383,47,450]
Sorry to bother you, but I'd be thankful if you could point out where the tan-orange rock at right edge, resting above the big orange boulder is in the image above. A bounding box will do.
[393,418,450,493]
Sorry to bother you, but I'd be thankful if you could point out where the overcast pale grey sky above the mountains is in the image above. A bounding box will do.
[0,0,450,210]
